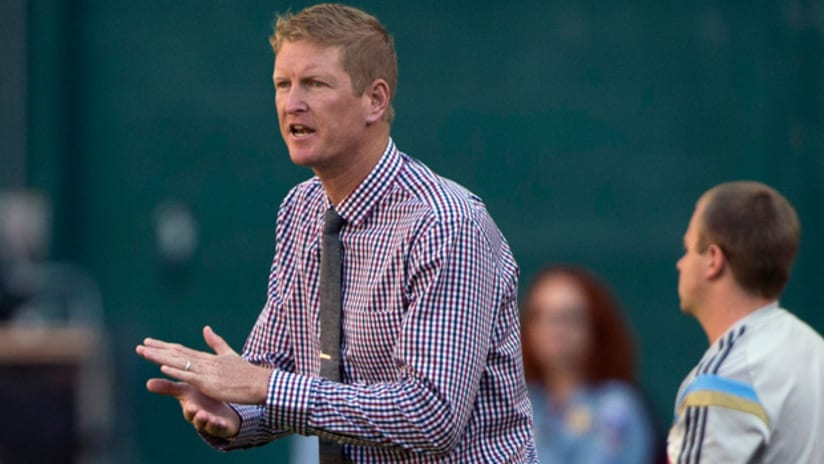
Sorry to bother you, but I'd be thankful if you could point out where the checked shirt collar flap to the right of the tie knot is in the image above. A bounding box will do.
[327,137,401,226]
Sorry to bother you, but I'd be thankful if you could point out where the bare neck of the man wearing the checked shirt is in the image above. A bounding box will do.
[314,131,389,205]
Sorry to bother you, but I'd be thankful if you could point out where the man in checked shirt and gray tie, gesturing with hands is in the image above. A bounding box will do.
[137,4,537,463]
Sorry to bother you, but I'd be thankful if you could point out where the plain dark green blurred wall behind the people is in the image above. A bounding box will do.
[6,0,824,463]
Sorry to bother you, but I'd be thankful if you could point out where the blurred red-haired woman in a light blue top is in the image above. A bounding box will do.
[522,267,655,464]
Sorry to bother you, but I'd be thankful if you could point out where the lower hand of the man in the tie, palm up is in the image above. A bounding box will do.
[146,379,240,439]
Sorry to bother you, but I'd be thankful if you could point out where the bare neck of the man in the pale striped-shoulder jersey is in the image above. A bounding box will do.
[696,288,773,345]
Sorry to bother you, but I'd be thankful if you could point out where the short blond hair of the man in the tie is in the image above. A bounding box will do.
[269,3,398,122]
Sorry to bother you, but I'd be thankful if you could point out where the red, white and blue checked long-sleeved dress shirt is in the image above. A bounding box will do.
[222,140,537,463]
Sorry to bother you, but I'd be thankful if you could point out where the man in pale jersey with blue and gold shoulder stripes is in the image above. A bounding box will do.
[668,182,824,464]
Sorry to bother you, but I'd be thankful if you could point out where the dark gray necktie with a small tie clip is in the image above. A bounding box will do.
[319,207,345,464]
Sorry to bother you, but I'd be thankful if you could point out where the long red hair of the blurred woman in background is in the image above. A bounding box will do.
[521,265,635,384]
